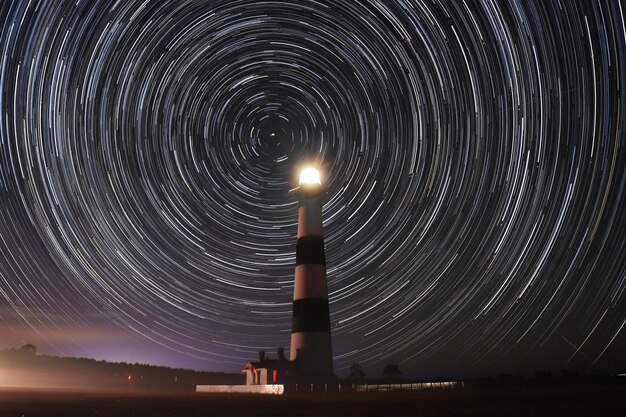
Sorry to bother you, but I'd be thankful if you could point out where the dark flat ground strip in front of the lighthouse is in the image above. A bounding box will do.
[0,385,626,417]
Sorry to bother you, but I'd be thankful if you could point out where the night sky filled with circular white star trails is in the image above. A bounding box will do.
[0,0,626,376]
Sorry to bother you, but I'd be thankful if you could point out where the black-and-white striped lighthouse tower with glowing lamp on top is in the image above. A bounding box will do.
[290,168,333,380]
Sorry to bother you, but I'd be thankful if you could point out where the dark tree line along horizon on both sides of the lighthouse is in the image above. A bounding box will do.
[0,345,626,384]
